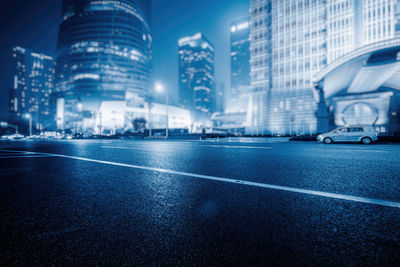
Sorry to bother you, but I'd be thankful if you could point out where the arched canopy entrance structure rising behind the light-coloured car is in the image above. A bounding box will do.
[314,38,400,133]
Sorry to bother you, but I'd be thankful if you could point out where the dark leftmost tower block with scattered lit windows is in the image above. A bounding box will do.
[9,47,54,130]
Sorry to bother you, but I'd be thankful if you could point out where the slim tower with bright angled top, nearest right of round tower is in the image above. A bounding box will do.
[179,33,216,115]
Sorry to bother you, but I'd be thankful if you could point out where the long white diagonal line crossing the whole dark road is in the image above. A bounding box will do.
[1,152,400,208]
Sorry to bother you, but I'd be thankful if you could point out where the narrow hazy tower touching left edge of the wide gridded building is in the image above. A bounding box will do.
[227,17,251,111]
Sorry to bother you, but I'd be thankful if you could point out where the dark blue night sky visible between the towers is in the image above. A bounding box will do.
[0,0,250,119]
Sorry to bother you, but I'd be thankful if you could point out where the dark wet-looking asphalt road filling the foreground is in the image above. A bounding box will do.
[0,139,400,266]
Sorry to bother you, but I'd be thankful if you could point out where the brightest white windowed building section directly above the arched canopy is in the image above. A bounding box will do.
[326,0,400,64]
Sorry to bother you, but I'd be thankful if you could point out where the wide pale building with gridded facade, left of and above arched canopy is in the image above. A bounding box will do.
[248,0,400,134]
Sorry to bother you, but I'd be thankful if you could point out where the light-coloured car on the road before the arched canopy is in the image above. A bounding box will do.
[317,126,378,145]
